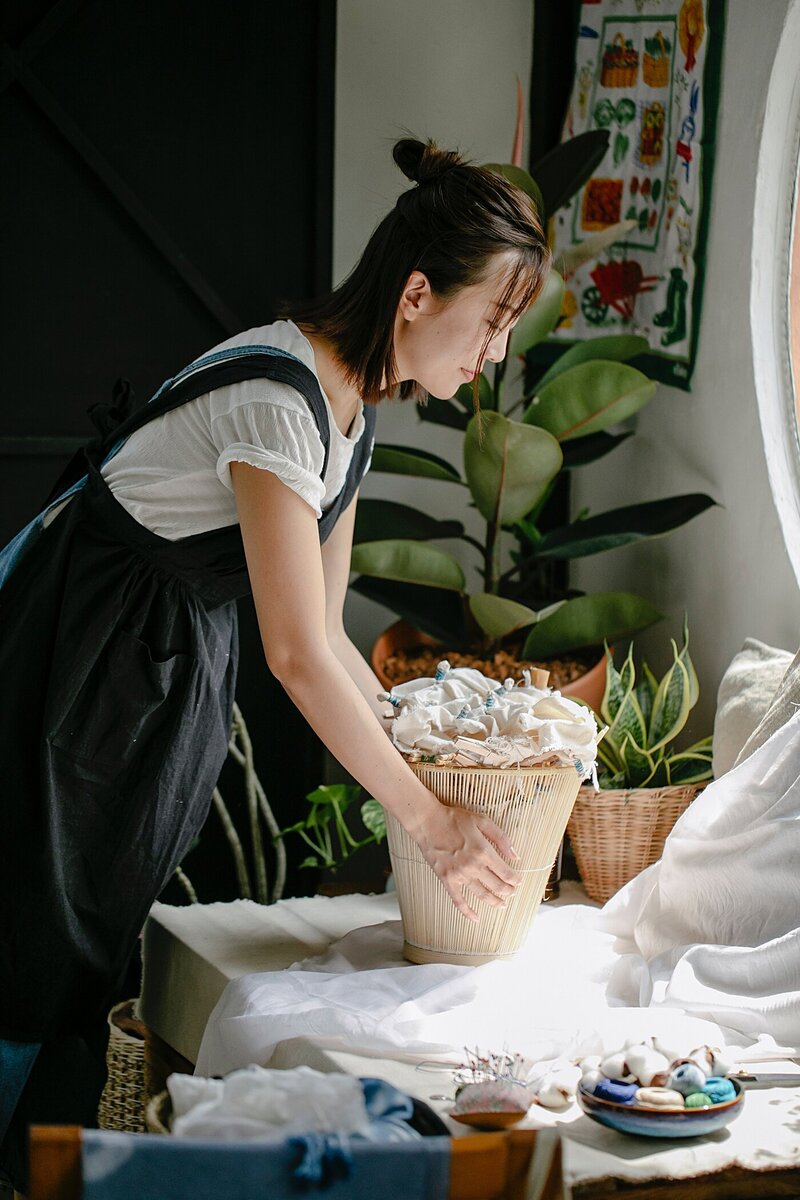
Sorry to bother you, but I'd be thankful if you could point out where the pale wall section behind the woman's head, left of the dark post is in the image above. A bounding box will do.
[333,0,534,650]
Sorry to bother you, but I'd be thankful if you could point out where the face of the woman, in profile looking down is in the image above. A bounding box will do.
[395,253,525,400]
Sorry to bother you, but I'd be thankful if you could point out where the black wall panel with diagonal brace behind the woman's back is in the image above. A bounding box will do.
[0,0,336,899]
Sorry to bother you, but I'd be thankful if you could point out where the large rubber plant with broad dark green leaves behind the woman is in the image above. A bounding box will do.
[351,100,714,660]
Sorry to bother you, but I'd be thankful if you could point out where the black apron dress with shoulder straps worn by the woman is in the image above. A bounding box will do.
[0,348,375,1042]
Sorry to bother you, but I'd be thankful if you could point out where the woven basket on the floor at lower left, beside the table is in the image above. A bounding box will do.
[97,1000,145,1133]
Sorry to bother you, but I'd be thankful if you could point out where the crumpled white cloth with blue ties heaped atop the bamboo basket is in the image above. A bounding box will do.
[386,661,597,775]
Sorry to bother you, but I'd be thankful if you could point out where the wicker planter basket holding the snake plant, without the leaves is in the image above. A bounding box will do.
[567,784,704,904]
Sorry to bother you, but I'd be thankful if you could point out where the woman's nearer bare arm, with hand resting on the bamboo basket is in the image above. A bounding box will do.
[230,463,519,918]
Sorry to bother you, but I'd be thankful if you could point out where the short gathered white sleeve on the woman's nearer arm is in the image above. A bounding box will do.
[210,379,325,518]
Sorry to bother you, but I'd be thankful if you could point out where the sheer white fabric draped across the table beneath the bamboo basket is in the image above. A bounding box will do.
[198,712,800,1074]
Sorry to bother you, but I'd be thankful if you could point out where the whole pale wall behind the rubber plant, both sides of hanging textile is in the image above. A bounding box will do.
[333,0,800,736]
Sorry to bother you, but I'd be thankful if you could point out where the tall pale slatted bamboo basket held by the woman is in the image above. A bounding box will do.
[386,763,581,966]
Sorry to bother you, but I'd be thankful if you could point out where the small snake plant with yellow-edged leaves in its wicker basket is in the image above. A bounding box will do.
[567,625,711,904]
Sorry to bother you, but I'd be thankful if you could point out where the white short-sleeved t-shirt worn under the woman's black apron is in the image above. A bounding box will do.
[102,320,365,541]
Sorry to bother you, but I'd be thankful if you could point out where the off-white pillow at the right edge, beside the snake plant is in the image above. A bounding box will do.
[712,637,792,779]
